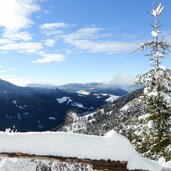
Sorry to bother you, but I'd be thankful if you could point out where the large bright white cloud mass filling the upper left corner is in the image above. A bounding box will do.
[0,0,43,53]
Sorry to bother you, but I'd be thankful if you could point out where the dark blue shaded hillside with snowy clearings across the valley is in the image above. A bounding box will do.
[0,80,127,131]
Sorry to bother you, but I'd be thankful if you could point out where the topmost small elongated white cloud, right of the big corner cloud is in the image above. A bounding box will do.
[39,23,70,30]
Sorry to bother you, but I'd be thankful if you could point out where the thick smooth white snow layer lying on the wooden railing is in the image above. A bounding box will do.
[0,130,162,171]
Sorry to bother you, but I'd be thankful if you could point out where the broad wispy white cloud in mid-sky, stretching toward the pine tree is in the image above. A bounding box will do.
[63,28,137,54]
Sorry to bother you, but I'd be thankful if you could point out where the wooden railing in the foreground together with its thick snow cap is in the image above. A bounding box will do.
[0,131,162,171]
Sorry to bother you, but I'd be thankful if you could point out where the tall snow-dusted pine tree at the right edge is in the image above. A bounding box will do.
[136,4,171,160]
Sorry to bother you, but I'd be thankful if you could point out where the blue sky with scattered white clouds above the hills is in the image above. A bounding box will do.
[0,0,171,85]
